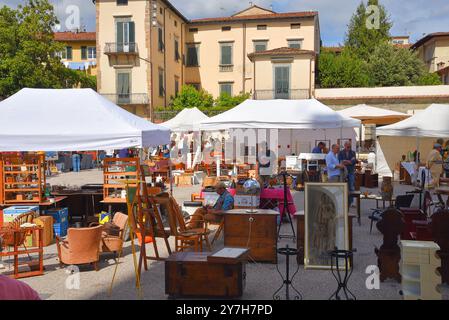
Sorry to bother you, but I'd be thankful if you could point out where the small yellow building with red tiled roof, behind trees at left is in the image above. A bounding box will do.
[55,31,97,76]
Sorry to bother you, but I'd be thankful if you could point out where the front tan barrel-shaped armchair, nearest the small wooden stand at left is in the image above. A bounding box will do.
[56,226,103,271]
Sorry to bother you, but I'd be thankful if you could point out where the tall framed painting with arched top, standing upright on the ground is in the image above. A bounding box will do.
[304,183,349,269]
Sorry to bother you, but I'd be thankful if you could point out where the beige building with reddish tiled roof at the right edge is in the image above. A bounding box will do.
[412,32,449,72]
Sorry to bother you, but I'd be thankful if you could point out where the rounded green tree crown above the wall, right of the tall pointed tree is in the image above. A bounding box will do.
[369,43,440,87]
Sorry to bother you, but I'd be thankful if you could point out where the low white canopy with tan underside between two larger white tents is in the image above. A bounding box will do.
[337,104,410,124]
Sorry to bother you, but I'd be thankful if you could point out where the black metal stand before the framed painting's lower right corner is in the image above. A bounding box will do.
[329,249,357,300]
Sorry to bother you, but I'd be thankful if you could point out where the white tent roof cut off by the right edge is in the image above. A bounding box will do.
[376,104,449,138]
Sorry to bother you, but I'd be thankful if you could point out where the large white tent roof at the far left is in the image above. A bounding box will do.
[0,88,170,151]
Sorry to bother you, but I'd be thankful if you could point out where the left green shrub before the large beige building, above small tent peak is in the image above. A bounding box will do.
[171,85,214,110]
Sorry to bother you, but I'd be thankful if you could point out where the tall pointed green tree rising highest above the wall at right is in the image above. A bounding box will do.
[345,0,392,60]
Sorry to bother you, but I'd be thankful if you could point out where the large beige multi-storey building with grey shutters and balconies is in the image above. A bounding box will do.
[96,0,320,117]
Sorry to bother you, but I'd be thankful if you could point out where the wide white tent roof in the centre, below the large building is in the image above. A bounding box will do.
[201,99,360,130]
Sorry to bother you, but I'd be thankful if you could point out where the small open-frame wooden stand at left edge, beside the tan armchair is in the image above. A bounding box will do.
[0,226,44,279]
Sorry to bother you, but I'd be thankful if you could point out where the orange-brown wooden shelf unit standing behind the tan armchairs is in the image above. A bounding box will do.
[103,158,140,203]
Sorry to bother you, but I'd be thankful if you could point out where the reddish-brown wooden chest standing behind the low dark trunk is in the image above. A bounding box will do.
[223,209,279,263]
